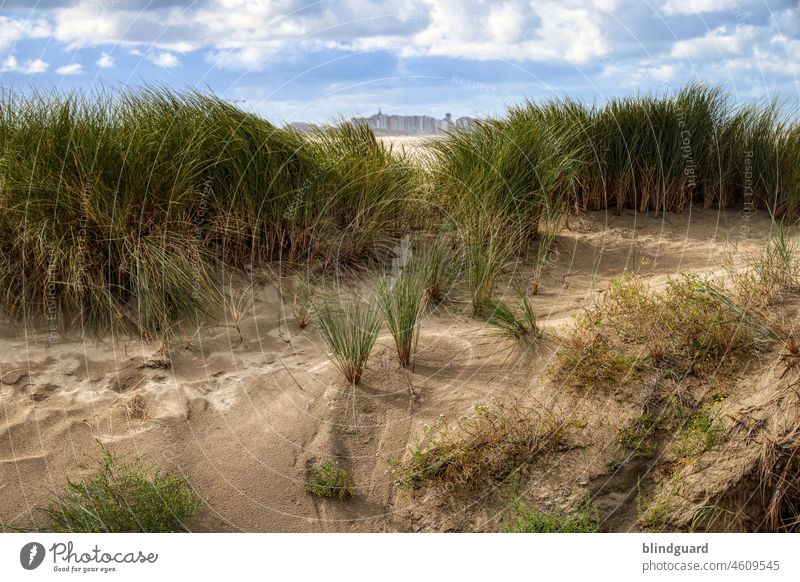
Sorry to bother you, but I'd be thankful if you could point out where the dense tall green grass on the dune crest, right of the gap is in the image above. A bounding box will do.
[438,82,800,224]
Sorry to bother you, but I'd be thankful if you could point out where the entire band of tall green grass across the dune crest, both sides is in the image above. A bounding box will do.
[0,84,800,342]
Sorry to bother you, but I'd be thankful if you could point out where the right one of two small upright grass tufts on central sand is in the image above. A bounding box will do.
[378,270,425,368]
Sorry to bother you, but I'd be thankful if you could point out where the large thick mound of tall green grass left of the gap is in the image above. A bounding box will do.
[0,88,417,334]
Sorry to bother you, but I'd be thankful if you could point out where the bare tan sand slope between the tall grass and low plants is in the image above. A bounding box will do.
[0,210,784,531]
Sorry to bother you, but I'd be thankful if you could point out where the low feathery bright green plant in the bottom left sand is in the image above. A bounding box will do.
[41,449,202,533]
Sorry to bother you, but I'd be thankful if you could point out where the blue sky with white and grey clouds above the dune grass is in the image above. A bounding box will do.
[0,0,800,122]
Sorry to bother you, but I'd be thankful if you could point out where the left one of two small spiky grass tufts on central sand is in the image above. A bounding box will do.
[315,297,381,384]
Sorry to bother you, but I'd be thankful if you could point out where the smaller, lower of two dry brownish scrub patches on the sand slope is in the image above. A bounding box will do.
[391,402,564,490]
